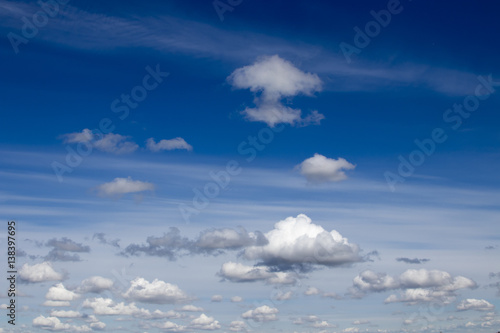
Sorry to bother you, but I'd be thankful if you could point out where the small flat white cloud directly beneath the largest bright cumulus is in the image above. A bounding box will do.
[218,261,297,284]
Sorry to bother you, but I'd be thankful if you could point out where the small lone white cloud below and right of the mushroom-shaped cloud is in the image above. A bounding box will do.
[298,154,356,184]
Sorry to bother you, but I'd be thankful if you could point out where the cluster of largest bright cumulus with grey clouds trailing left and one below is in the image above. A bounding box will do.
[121,214,363,272]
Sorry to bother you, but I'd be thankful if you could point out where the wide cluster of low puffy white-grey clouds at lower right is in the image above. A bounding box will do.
[351,269,477,304]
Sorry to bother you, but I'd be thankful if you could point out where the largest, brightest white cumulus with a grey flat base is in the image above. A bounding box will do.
[244,214,362,266]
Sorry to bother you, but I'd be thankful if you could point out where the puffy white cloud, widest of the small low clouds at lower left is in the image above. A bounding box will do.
[123,278,189,304]
